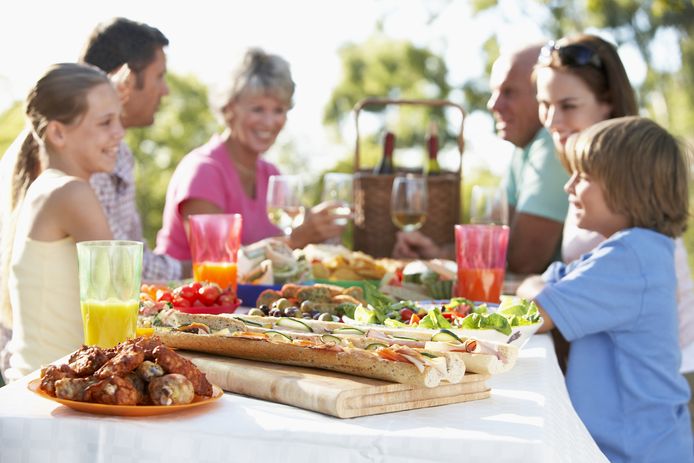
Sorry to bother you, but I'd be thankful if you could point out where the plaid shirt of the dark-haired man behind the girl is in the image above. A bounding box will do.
[90,143,182,281]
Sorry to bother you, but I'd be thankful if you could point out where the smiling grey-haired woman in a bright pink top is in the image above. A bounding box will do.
[157,49,343,260]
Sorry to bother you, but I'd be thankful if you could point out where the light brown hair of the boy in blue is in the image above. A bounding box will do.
[560,116,691,238]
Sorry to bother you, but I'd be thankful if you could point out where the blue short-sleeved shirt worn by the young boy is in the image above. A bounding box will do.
[536,228,694,463]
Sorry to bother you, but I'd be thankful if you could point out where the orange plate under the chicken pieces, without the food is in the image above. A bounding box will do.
[27,379,224,416]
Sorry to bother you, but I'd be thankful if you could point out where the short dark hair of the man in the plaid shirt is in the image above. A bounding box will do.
[79,18,169,88]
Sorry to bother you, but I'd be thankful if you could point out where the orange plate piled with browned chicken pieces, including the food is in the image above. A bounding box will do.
[28,337,223,416]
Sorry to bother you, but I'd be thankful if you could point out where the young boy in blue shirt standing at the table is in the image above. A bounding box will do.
[518,117,694,463]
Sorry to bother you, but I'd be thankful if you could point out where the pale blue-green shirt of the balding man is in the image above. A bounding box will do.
[505,129,569,223]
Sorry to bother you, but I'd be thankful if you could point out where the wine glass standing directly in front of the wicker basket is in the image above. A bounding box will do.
[390,174,428,232]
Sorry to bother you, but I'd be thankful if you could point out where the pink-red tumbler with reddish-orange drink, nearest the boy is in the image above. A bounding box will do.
[455,224,509,303]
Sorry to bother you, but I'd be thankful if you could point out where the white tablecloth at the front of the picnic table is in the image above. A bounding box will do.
[0,335,607,463]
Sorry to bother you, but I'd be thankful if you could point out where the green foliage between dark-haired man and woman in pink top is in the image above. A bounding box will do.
[126,72,220,244]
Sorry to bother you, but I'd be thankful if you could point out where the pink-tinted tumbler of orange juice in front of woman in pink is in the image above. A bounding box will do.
[188,214,243,294]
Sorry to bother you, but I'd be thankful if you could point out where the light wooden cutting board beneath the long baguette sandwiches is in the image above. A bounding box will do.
[179,351,490,418]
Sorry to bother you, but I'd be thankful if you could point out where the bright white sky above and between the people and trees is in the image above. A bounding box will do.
[0,0,648,179]
